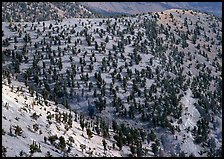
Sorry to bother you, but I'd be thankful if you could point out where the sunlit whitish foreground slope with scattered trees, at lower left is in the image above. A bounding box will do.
[2,80,127,157]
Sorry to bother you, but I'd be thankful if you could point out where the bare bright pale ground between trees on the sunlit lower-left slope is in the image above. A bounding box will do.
[2,80,126,157]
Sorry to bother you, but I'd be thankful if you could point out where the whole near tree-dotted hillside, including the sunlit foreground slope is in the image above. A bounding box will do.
[2,9,222,157]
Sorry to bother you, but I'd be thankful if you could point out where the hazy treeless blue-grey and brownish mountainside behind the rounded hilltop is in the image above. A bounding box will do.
[81,2,222,16]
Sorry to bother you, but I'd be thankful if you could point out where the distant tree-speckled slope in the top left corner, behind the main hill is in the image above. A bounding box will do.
[2,2,96,22]
